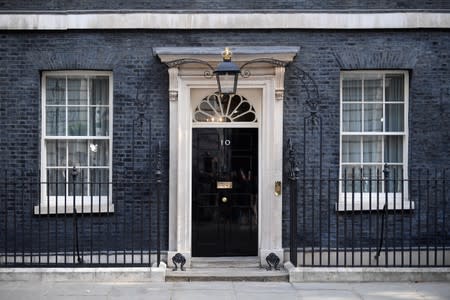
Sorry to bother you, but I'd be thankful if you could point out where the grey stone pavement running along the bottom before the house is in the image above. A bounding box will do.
[0,281,450,300]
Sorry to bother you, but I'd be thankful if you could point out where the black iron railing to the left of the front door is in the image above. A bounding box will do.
[0,166,162,267]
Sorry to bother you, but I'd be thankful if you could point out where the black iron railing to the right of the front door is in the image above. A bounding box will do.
[287,168,450,267]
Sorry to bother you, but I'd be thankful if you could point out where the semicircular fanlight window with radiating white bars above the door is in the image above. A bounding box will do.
[193,94,257,123]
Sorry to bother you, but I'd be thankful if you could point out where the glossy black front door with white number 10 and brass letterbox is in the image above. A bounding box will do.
[192,128,258,256]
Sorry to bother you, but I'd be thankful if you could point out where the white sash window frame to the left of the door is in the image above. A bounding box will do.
[34,70,114,215]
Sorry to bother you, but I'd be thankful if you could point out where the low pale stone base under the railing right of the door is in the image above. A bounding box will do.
[284,262,450,282]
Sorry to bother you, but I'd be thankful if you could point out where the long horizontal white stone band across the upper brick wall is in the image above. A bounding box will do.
[0,11,450,30]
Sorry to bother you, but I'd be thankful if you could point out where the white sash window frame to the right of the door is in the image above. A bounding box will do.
[336,70,414,211]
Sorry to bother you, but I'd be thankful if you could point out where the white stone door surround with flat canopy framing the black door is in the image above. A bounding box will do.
[154,47,299,267]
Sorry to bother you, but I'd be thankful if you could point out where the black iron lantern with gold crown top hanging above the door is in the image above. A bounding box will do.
[214,48,241,94]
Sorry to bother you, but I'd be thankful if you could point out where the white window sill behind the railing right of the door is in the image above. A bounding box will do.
[336,193,414,212]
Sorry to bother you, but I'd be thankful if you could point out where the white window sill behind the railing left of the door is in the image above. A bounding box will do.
[34,196,114,215]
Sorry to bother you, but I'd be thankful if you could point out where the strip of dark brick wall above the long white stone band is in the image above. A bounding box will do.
[0,0,450,10]
